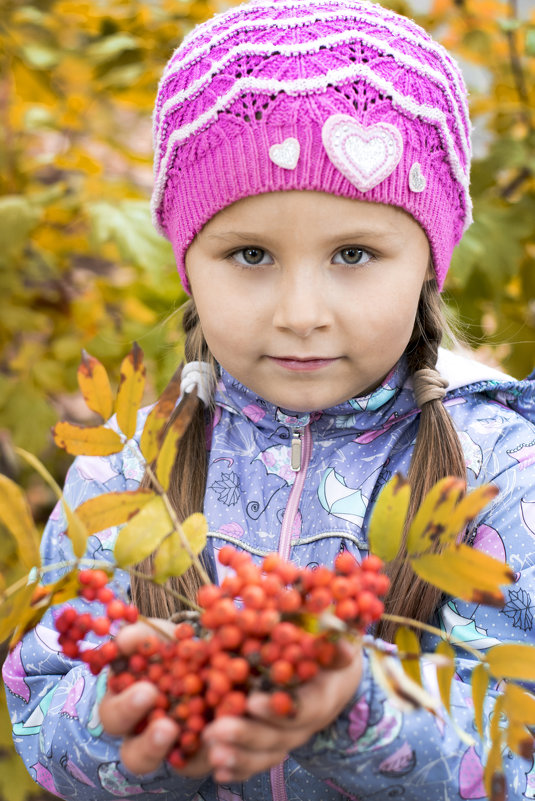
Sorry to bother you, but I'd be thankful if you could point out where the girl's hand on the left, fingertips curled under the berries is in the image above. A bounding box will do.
[99,620,210,778]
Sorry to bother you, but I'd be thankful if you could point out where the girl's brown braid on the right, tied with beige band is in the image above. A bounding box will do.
[377,282,466,641]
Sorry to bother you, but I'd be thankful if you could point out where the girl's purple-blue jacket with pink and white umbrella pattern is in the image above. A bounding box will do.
[3,351,535,801]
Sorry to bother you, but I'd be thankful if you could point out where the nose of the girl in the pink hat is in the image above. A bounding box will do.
[273,268,332,338]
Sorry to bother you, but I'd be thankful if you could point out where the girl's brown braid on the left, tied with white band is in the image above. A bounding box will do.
[130,300,216,618]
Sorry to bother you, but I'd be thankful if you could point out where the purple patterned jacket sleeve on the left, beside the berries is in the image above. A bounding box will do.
[3,441,211,801]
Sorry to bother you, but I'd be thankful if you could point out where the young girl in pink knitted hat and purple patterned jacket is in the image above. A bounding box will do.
[4,0,535,801]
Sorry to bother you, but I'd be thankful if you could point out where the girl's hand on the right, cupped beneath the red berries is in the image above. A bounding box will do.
[203,641,362,783]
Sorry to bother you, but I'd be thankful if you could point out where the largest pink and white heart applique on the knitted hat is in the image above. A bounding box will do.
[321,114,403,192]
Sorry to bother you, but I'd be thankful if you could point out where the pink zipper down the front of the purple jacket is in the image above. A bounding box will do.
[269,426,312,801]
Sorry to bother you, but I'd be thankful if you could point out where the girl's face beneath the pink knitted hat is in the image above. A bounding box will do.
[186,191,429,412]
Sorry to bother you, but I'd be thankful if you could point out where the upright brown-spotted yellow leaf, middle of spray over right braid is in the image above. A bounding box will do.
[407,476,465,556]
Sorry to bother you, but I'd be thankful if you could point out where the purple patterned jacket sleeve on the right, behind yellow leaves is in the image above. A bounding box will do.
[292,412,535,801]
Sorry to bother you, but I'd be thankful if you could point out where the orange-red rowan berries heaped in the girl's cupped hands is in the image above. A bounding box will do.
[56,545,389,768]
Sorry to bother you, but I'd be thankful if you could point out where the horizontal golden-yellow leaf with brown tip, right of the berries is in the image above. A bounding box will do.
[411,544,514,606]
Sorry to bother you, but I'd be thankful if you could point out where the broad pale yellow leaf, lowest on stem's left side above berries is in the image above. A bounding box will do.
[113,495,173,567]
